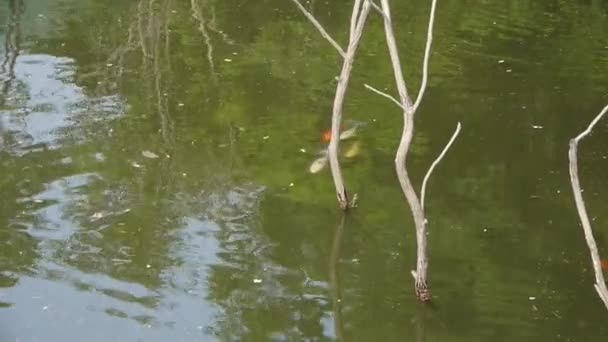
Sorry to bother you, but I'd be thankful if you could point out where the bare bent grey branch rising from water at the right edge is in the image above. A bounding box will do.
[568,105,608,309]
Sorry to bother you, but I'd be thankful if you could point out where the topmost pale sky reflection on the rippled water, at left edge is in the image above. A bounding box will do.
[0,54,124,154]
